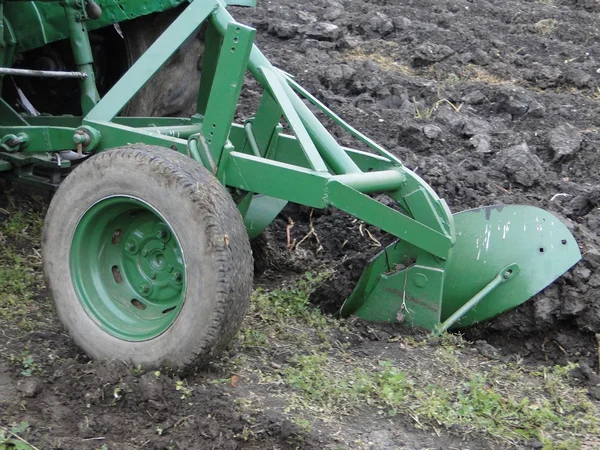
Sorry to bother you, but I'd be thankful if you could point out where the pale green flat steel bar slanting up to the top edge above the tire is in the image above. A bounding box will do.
[84,0,220,123]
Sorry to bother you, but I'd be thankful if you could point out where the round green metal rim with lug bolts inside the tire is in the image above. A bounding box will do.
[70,196,186,341]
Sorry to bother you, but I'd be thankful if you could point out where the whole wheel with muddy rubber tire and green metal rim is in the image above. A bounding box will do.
[43,145,253,369]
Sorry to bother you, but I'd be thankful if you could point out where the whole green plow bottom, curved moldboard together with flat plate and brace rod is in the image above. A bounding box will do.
[340,206,581,331]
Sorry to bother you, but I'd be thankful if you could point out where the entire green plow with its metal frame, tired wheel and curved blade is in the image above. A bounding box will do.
[0,0,581,366]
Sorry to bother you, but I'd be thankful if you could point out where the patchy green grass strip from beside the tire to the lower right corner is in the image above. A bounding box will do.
[232,276,600,450]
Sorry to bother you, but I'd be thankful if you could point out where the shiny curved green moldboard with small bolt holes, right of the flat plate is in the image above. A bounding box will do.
[441,206,581,327]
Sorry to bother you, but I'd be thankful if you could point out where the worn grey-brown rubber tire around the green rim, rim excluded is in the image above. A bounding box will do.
[42,145,253,370]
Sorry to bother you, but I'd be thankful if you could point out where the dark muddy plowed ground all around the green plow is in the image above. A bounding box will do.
[0,0,600,449]
